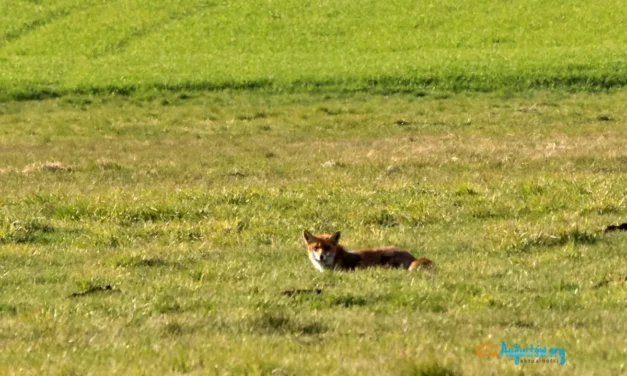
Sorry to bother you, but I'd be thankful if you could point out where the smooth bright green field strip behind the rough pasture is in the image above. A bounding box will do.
[0,0,627,99]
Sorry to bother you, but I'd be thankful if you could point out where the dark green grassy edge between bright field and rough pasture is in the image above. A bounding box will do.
[0,73,627,102]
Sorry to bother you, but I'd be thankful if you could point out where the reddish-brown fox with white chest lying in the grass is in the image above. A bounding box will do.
[303,230,435,272]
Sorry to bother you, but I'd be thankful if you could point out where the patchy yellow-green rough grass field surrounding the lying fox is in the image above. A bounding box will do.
[0,92,627,375]
